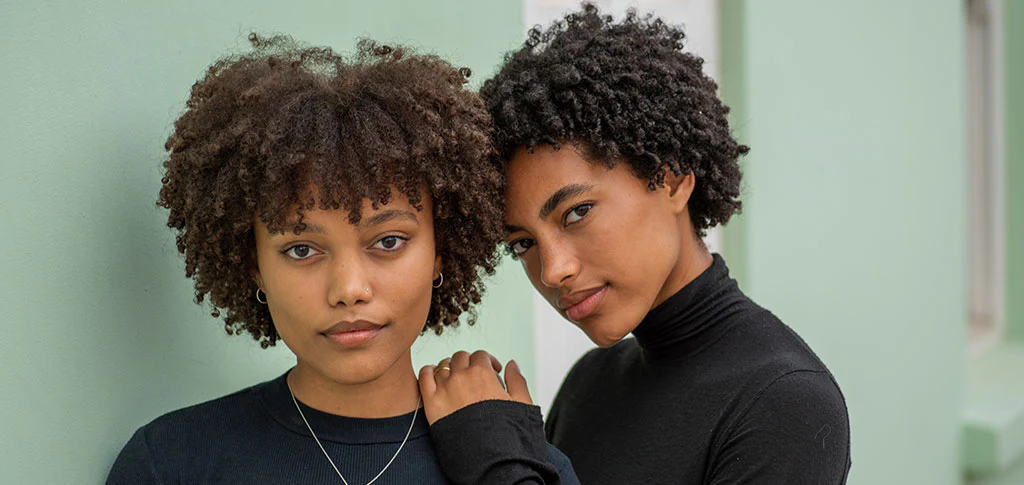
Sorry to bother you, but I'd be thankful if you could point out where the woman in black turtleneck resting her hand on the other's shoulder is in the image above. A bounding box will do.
[420,5,850,485]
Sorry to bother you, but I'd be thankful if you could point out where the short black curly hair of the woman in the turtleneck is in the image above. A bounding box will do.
[480,3,749,236]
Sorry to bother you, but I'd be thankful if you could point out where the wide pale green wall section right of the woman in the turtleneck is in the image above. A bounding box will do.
[723,0,967,485]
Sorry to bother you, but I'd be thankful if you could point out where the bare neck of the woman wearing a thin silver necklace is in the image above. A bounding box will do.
[287,352,420,418]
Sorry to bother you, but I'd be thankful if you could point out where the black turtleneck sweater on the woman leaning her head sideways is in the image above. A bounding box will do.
[432,255,850,485]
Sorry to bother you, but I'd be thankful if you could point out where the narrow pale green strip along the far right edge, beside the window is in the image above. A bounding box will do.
[1002,0,1024,343]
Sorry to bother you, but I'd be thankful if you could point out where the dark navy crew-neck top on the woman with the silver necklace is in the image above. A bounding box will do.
[106,373,579,485]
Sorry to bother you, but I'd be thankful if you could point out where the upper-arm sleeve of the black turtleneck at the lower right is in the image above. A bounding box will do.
[710,370,850,485]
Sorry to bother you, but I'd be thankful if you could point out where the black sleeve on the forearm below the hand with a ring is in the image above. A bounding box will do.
[430,400,580,485]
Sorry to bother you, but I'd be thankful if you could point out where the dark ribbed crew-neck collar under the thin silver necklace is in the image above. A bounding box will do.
[255,372,430,444]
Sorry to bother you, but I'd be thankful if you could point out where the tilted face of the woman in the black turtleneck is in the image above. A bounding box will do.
[506,144,692,346]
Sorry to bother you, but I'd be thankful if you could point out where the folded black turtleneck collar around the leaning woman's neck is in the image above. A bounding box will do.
[633,254,751,361]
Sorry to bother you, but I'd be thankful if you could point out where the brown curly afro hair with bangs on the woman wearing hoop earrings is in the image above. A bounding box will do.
[158,34,504,348]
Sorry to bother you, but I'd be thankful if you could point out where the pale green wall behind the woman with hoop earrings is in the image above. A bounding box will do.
[0,0,532,484]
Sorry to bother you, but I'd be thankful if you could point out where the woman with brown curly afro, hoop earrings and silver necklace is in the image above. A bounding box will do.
[108,35,578,484]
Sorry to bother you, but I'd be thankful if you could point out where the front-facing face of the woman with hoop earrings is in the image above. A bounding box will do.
[255,189,440,385]
